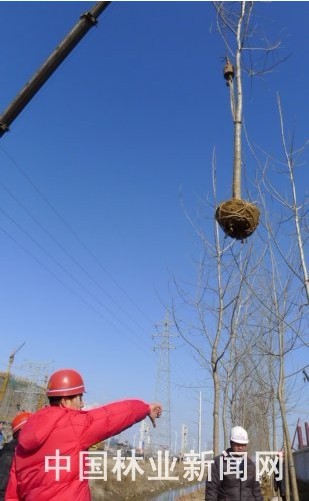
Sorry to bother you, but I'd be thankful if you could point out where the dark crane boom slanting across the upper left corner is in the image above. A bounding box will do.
[0,2,111,137]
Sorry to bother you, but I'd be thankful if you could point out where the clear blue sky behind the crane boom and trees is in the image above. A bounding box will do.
[0,1,309,450]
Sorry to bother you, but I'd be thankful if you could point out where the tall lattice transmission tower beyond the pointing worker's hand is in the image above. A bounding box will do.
[153,314,174,450]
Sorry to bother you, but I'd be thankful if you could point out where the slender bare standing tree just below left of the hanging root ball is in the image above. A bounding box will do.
[172,149,260,454]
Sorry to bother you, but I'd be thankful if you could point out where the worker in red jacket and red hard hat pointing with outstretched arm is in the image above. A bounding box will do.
[5,369,162,501]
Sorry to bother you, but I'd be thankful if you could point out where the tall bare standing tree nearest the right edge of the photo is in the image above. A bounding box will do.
[242,83,309,499]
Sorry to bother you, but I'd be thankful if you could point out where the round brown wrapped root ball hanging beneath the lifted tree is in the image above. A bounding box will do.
[216,198,260,240]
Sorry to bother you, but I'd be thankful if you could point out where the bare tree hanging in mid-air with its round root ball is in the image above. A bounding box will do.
[215,2,260,240]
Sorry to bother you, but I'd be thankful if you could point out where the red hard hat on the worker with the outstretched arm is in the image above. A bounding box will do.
[47,369,85,397]
